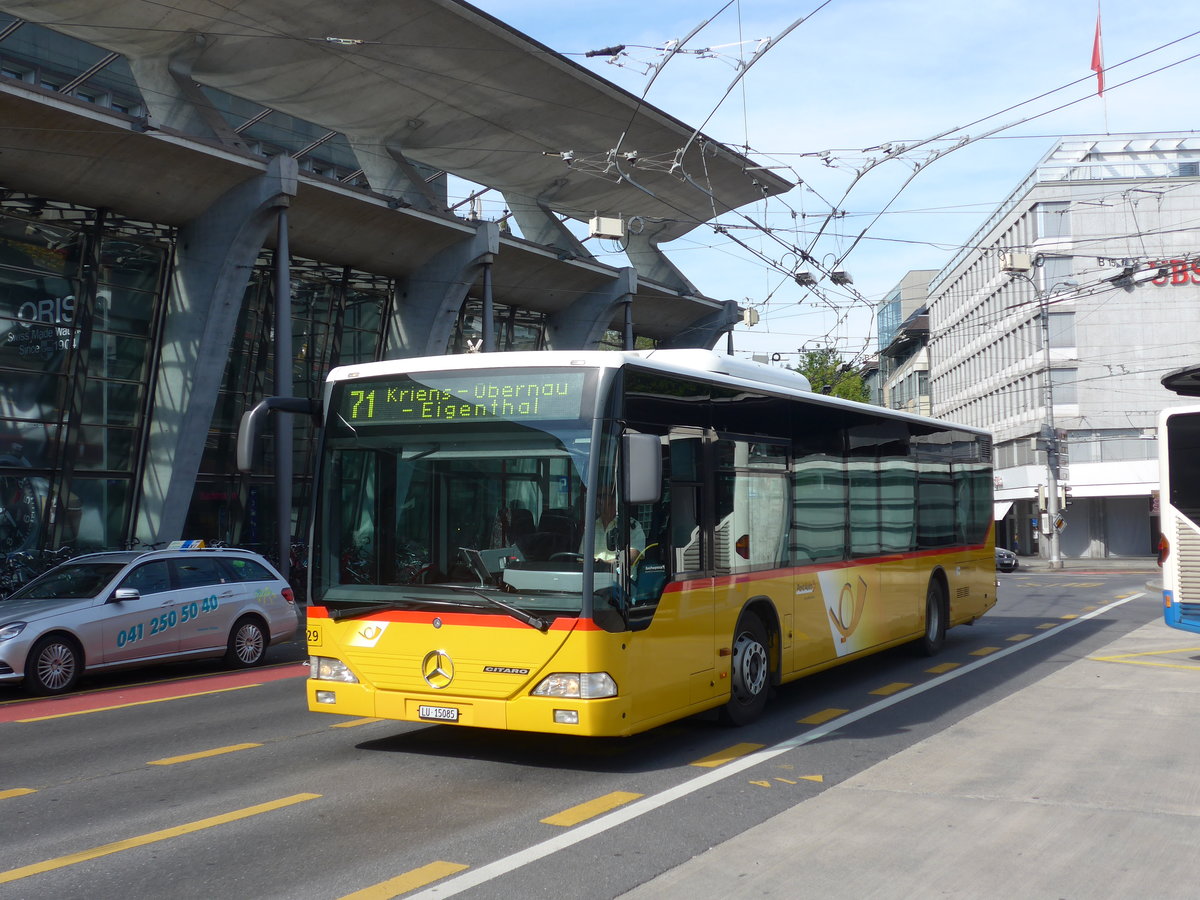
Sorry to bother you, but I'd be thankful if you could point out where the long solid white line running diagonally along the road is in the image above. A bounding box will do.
[409,592,1146,900]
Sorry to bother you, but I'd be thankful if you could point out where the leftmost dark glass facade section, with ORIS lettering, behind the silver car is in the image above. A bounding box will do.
[0,204,168,552]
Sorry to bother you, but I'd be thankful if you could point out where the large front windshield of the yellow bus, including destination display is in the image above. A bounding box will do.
[312,370,595,616]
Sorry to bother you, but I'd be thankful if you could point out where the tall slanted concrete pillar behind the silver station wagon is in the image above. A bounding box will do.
[137,156,298,542]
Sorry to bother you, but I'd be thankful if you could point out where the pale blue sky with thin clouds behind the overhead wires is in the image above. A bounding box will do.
[476,0,1200,359]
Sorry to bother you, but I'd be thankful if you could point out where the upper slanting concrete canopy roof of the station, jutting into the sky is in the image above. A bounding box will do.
[7,0,792,241]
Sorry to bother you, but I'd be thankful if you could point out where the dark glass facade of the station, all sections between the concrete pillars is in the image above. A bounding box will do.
[0,192,559,564]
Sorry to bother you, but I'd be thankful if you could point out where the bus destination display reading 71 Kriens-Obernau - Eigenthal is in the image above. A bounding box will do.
[338,371,587,425]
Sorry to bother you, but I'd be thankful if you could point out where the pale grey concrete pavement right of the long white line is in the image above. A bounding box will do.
[624,580,1200,900]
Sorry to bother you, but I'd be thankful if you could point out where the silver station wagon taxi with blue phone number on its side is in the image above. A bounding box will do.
[0,550,299,694]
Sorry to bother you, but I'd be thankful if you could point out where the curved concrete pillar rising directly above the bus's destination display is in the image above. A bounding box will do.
[380,222,500,359]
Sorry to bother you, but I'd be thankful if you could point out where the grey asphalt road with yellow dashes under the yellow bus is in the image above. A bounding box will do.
[0,572,1159,900]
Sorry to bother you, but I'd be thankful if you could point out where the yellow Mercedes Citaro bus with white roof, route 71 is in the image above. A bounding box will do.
[295,350,996,736]
